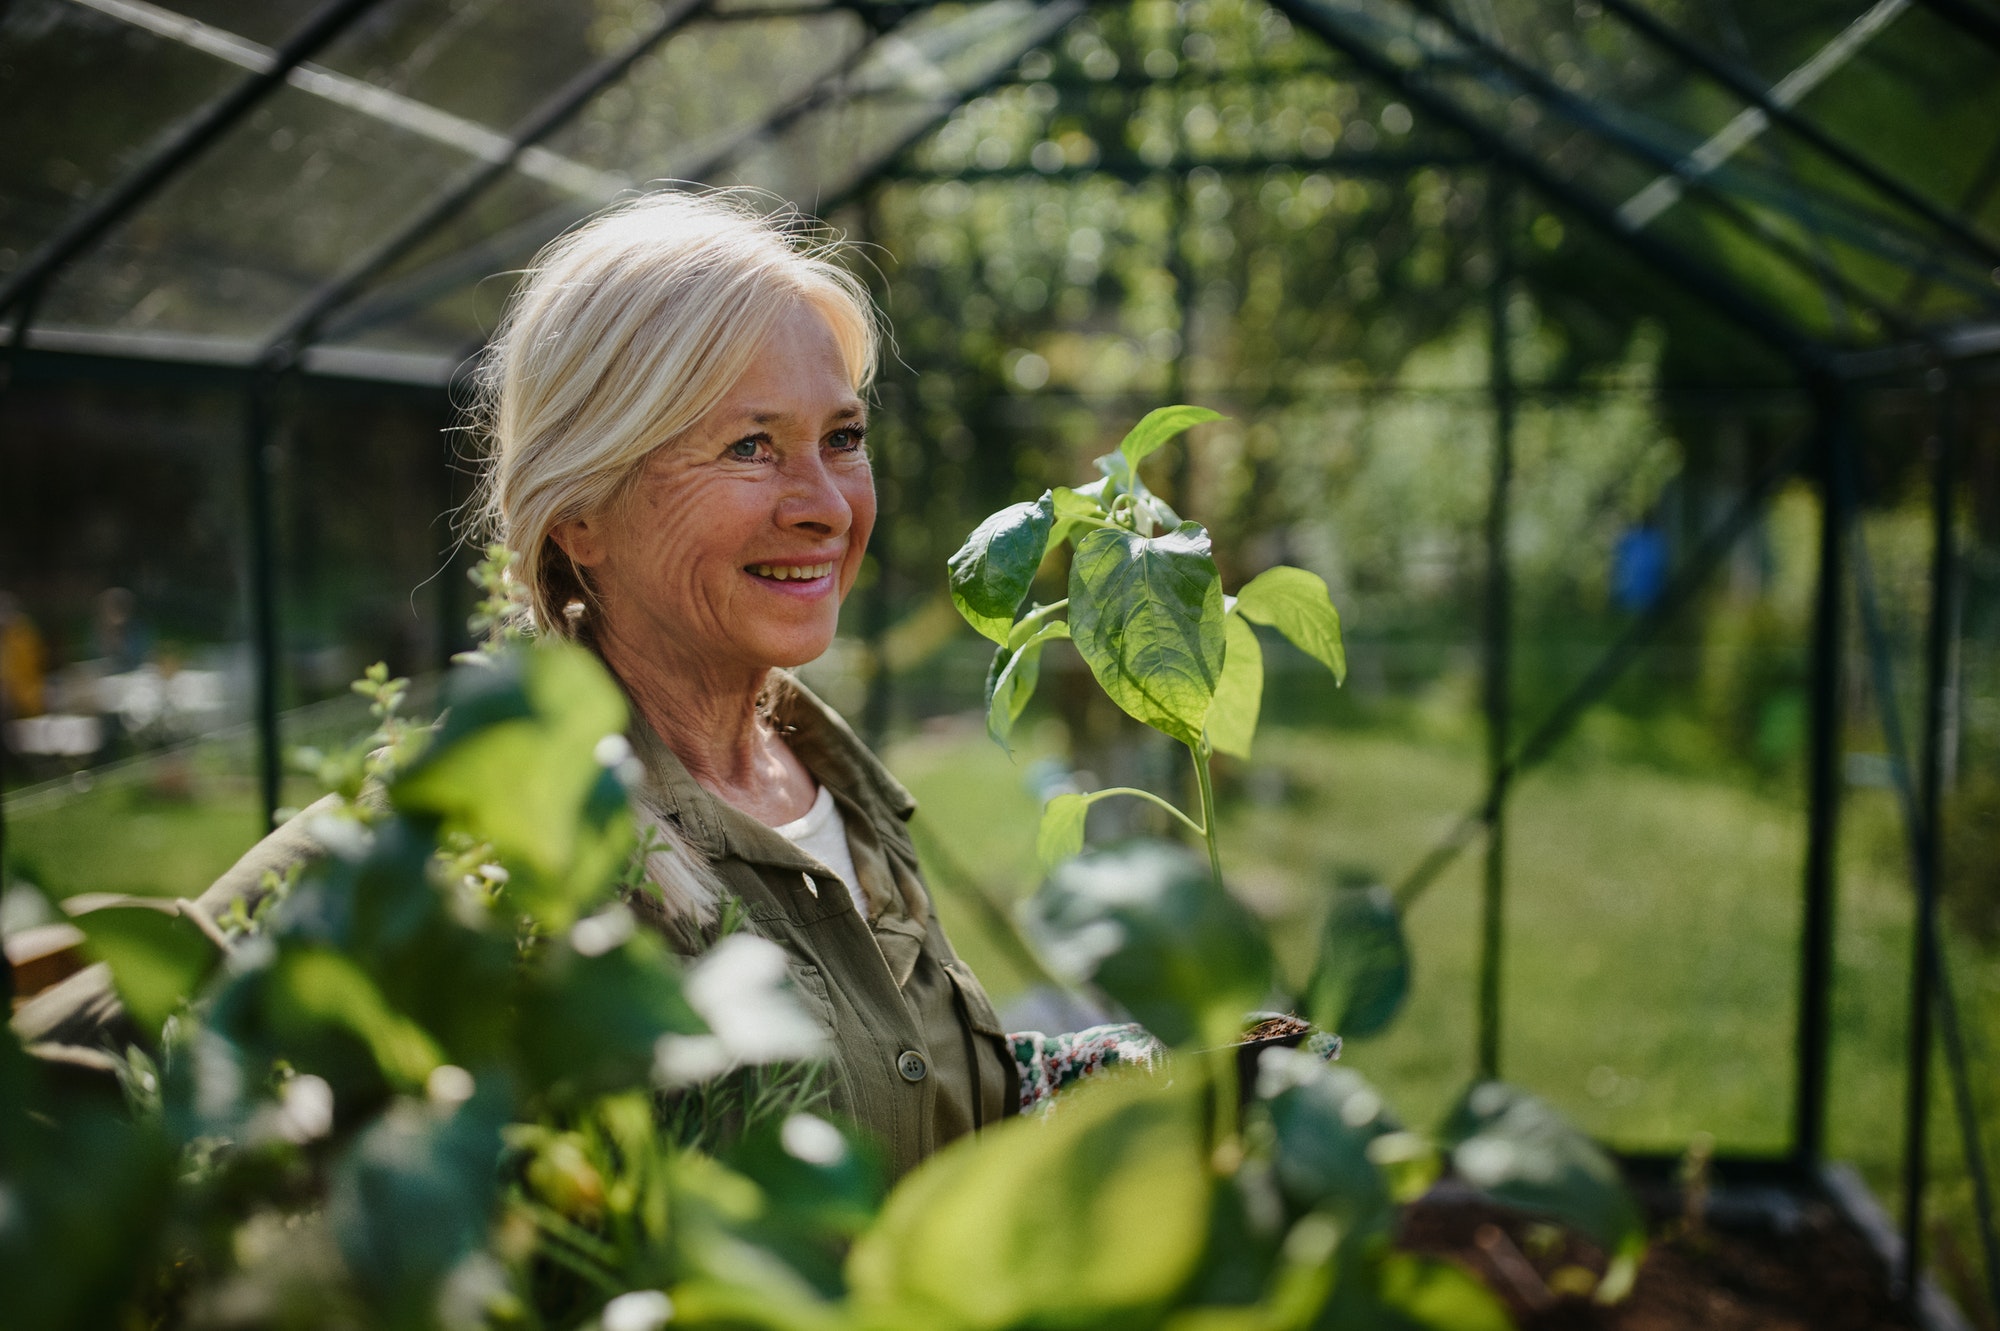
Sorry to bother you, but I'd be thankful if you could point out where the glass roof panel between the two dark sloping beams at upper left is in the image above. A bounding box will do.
[31,0,630,336]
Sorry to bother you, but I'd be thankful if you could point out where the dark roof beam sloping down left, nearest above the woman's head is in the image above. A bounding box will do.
[260,0,710,368]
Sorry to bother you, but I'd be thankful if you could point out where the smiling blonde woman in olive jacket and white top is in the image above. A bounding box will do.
[474,194,1020,1173]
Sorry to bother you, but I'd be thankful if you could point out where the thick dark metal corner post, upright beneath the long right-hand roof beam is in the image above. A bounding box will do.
[1792,376,1852,1177]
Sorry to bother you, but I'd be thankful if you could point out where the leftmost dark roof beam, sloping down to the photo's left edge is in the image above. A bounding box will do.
[0,0,380,321]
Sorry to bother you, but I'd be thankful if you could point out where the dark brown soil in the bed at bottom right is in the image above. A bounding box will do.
[1400,1185,1916,1331]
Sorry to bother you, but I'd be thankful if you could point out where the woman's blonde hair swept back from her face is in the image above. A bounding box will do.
[474,190,882,636]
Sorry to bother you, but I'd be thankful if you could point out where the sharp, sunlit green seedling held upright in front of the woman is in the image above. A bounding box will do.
[948,406,1348,883]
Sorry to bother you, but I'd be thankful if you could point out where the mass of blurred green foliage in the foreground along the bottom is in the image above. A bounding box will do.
[0,648,1640,1331]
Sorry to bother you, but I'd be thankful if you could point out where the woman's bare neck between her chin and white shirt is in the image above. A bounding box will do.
[596,618,818,827]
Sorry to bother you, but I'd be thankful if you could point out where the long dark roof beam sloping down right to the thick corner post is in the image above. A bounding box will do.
[1270,0,1828,370]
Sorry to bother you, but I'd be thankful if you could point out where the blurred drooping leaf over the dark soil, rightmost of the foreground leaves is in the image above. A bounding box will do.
[1438,1081,1646,1299]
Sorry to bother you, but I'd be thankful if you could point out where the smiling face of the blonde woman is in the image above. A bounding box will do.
[556,302,876,673]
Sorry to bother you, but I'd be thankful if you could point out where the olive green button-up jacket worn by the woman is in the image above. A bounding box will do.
[14,677,1020,1175]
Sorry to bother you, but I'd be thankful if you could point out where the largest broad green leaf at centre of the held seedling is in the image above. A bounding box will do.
[1070,522,1224,745]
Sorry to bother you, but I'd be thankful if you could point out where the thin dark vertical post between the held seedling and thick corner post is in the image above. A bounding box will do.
[1478,172,1514,1081]
